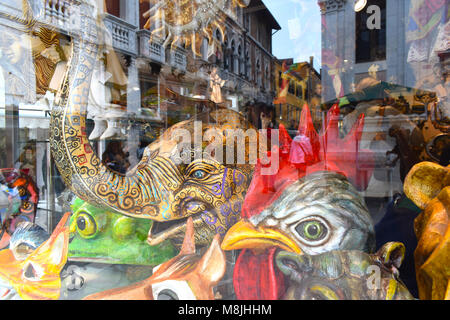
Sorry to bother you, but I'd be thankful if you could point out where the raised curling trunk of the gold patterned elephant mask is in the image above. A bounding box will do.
[50,1,166,218]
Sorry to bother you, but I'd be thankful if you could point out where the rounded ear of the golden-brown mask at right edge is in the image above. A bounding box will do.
[403,162,450,210]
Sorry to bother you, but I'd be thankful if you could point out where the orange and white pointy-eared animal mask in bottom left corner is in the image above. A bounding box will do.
[0,213,70,300]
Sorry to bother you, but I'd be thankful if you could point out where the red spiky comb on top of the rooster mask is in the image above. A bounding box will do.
[242,104,374,218]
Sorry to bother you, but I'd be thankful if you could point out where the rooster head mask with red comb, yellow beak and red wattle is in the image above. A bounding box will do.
[222,105,375,300]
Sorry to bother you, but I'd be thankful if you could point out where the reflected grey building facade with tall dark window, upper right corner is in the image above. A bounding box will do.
[318,0,450,105]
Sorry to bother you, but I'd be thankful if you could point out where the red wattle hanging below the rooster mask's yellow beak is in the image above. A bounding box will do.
[233,248,285,300]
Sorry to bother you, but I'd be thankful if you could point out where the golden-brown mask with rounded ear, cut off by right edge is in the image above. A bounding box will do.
[404,162,450,300]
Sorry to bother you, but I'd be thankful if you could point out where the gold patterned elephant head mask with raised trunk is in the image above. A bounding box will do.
[50,3,254,245]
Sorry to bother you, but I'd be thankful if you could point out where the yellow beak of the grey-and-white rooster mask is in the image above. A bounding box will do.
[222,220,302,253]
